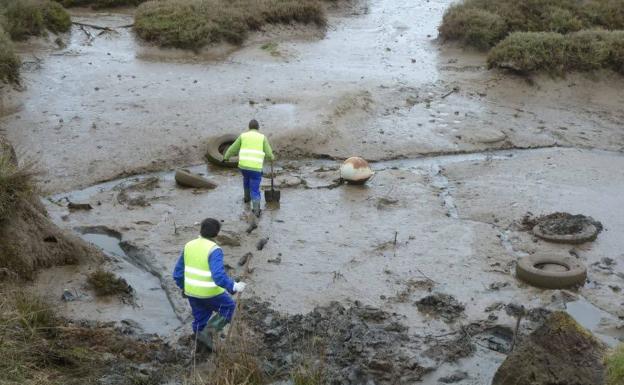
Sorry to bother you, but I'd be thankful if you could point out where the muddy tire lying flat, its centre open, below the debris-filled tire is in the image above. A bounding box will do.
[516,255,587,289]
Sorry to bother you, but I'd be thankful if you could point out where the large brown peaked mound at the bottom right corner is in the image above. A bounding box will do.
[492,312,606,385]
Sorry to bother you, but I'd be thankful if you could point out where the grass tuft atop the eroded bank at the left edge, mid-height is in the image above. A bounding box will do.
[0,152,35,221]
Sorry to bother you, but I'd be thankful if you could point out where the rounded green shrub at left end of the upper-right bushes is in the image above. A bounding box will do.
[439,7,507,49]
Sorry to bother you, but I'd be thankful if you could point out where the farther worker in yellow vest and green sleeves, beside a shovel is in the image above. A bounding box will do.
[223,119,275,217]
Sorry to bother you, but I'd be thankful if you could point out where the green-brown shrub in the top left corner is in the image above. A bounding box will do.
[0,0,71,40]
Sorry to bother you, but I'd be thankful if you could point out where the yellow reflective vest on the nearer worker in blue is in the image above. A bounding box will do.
[184,237,225,298]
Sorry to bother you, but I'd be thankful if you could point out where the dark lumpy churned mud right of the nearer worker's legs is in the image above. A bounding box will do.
[241,301,432,384]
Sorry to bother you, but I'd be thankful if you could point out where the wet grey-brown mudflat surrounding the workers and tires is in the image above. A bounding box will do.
[1,0,624,384]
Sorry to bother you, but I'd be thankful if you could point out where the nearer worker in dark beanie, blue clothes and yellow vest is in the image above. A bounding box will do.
[173,218,245,350]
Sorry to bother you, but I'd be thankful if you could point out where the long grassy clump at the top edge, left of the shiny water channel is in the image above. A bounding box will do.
[134,0,326,49]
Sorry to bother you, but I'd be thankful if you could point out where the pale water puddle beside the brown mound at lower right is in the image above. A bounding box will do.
[566,299,624,347]
